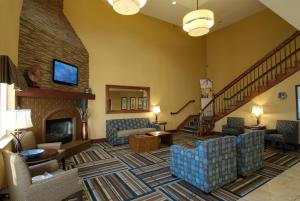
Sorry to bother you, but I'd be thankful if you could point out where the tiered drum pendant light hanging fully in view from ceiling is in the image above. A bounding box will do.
[183,9,214,37]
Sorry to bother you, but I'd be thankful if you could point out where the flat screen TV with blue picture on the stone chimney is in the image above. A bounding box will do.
[53,59,78,86]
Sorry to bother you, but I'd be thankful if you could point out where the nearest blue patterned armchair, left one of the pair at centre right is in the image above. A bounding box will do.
[171,136,237,193]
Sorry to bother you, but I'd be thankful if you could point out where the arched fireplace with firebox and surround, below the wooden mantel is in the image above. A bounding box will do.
[18,97,82,143]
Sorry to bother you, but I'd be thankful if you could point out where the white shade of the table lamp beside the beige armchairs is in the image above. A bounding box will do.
[6,109,33,131]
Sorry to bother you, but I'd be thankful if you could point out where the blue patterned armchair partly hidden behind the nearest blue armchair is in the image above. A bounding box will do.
[236,131,264,176]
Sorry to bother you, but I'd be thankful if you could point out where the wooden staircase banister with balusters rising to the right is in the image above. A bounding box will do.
[199,31,300,136]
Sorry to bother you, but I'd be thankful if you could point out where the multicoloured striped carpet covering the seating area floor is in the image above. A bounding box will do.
[66,134,300,201]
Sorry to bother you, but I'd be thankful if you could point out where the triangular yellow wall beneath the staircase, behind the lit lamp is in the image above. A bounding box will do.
[215,72,300,143]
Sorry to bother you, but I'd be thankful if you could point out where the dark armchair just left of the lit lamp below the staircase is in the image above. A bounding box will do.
[222,117,245,136]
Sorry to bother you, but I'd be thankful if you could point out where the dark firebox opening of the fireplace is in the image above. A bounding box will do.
[45,118,74,144]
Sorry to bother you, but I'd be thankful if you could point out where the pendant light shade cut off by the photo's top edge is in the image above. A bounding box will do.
[108,0,147,15]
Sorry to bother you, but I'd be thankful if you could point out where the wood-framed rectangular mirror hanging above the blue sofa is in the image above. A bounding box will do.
[106,85,150,114]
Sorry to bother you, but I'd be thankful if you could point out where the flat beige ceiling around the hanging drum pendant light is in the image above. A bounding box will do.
[141,0,266,31]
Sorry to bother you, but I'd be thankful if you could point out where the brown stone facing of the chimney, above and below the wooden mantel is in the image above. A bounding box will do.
[18,0,89,143]
